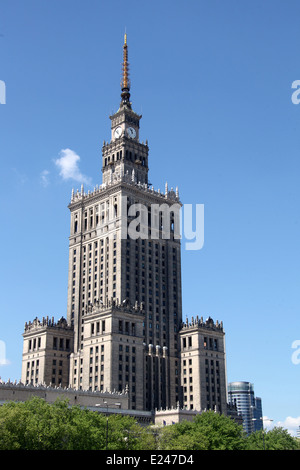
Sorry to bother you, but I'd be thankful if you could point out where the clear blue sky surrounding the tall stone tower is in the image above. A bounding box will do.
[0,0,300,432]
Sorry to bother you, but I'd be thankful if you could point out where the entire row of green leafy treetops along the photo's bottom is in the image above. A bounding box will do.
[0,398,299,450]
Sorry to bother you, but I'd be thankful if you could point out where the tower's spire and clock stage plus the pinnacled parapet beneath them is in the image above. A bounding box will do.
[69,35,179,210]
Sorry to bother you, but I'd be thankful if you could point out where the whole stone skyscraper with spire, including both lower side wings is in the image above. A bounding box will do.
[22,35,226,413]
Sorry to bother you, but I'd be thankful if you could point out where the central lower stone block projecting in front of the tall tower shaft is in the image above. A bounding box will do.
[70,301,145,410]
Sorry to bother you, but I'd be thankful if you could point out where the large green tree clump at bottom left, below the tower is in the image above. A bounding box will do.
[0,398,155,450]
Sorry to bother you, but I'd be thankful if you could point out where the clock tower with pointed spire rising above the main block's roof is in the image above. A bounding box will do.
[102,34,148,186]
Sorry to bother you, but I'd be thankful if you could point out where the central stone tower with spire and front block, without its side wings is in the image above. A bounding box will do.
[67,35,182,409]
